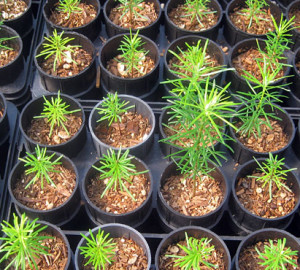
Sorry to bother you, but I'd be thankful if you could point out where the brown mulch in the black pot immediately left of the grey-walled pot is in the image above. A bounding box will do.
[26,112,82,145]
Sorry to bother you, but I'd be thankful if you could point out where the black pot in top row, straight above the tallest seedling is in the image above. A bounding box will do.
[165,0,223,41]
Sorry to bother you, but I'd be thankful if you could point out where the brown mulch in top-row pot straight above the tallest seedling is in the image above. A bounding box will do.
[168,5,219,32]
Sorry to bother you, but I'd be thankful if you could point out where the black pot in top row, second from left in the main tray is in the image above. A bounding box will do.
[103,0,162,40]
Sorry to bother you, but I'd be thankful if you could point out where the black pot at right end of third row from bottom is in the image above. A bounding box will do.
[228,105,296,164]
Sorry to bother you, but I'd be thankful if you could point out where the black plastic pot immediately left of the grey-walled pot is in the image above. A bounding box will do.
[19,94,86,157]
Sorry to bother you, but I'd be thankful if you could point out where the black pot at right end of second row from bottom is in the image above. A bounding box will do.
[229,158,300,233]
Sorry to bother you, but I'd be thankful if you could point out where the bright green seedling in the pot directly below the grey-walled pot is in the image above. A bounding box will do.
[93,148,148,201]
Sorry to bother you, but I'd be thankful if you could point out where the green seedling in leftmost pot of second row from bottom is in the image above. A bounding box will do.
[19,145,62,189]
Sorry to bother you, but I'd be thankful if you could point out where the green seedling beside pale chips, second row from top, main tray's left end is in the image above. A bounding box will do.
[36,29,80,71]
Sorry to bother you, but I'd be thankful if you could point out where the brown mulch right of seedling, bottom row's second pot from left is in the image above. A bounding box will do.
[82,237,148,270]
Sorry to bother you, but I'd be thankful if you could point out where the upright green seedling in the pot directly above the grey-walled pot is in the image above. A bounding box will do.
[118,29,148,77]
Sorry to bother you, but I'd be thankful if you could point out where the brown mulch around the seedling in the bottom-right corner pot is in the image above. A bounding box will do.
[239,239,300,270]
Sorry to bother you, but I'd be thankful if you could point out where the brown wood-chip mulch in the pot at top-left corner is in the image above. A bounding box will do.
[0,0,27,20]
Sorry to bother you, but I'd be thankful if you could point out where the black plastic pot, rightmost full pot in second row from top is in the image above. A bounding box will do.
[226,38,290,95]
